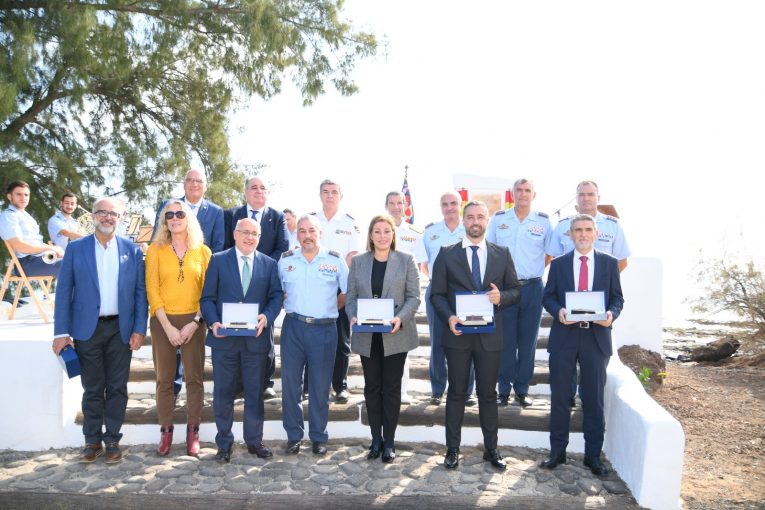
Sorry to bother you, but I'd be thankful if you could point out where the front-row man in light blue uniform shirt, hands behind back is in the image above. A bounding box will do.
[279,215,348,455]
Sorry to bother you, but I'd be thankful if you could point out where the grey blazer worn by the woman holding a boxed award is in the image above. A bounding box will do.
[345,250,420,357]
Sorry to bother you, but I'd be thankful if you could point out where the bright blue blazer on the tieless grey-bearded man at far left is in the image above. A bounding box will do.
[53,234,149,343]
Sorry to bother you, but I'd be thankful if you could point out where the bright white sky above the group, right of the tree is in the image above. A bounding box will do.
[218,0,765,314]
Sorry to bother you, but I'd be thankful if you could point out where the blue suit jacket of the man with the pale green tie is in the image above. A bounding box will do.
[200,248,284,353]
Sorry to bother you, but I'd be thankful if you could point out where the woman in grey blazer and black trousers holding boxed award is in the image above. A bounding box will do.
[345,214,420,463]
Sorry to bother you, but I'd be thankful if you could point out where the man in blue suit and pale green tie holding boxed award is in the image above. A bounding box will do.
[200,218,284,462]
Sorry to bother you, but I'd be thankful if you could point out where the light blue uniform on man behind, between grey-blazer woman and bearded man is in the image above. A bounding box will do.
[414,220,475,395]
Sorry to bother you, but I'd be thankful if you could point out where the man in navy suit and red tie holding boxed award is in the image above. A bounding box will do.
[541,214,624,475]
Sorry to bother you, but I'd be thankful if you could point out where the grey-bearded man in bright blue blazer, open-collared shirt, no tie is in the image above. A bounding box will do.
[53,198,149,463]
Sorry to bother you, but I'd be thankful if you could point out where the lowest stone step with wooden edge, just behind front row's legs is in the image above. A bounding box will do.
[76,393,582,432]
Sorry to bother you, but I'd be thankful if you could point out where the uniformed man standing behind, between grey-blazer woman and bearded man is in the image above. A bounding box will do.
[415,191,477,406]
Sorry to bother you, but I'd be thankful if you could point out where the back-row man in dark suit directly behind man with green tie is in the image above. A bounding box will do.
[225,177,290,399]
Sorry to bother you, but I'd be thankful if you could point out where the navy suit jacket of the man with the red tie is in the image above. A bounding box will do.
[542,250,624,356]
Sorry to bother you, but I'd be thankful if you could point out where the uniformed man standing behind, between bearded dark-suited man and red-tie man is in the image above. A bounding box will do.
[486,179,552,407]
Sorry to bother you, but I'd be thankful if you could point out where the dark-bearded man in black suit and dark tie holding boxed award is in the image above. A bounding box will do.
[430,201,521,470]
